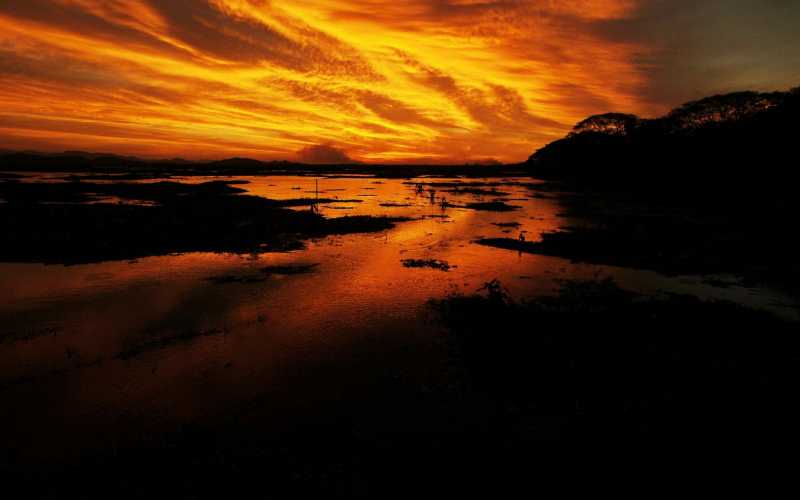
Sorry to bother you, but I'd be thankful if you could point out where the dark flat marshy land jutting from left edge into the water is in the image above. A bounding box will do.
[0,180,404,263]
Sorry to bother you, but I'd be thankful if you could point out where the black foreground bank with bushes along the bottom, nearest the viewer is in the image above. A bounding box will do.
[3,280,800,498]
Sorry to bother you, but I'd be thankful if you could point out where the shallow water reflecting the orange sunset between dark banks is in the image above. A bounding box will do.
[0,175,797,453]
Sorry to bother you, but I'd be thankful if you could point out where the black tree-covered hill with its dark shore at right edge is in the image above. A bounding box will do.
[520,88,800,292]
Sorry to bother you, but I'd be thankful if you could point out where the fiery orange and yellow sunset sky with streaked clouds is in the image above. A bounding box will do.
[0,0,800,163]
